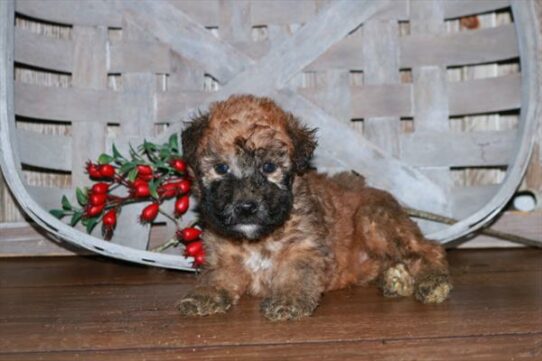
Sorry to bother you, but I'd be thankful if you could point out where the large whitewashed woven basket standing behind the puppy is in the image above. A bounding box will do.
[0,0,541,269]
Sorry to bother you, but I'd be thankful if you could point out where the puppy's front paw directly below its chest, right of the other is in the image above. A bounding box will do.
[260,297,318,321]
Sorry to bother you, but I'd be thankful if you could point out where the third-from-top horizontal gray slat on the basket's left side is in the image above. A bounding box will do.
[15,82,121,123]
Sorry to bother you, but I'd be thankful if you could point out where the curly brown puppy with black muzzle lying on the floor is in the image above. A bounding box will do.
[179,95,452,320]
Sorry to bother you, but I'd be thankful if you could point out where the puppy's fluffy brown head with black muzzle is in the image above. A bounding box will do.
[182,95,316,240]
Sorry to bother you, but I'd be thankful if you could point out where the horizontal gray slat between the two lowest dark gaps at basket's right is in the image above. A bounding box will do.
[400,130,517,167]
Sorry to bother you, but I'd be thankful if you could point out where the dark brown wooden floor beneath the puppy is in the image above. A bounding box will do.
[0,249,542,361]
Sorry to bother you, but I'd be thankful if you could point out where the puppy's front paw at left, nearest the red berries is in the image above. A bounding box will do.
[177,288,232,316]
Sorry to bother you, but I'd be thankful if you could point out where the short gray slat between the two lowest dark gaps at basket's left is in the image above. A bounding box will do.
[17,129,72,171]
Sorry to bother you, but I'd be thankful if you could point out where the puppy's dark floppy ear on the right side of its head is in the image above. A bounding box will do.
[286,114,317,173]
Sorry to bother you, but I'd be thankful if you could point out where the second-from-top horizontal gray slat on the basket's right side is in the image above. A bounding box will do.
[306,24,519,71]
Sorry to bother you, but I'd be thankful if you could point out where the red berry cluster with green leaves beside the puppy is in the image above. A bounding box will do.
[50,135,205,266]
